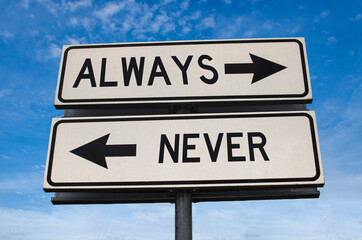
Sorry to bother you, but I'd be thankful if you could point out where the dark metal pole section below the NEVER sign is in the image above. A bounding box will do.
[175,191,192,240]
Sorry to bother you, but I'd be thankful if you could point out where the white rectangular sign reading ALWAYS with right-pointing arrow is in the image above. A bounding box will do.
[55,38,312,108]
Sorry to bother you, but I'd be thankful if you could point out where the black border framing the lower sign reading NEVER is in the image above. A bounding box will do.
[45,112,321,191]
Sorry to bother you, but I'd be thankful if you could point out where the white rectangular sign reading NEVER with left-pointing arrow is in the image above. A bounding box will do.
[44,111,324,191]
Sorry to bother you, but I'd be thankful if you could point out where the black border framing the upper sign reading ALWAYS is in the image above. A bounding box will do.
[56,39,312,107]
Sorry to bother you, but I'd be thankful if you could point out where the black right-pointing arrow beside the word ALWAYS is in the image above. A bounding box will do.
[225,53,287,84]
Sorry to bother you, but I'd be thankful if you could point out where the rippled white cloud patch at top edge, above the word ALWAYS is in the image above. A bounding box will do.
[84,0,216,40]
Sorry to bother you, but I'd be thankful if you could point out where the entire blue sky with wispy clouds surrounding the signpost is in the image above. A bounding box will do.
[0,0,362,240]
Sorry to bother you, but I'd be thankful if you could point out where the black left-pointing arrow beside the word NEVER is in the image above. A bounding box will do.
[70,134,136,169]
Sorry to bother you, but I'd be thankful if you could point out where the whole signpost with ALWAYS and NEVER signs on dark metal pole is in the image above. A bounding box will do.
[43,38,324,240]
